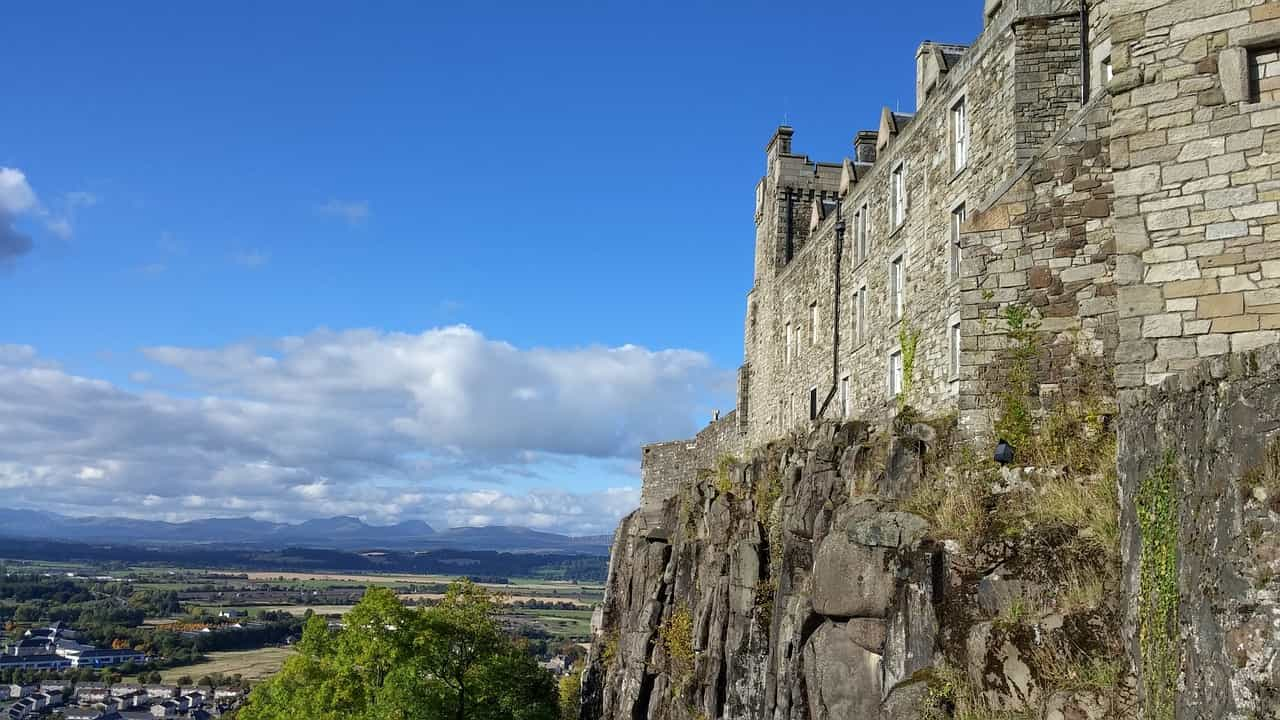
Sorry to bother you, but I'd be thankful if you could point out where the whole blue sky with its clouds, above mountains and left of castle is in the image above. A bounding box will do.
[0,0,982,532]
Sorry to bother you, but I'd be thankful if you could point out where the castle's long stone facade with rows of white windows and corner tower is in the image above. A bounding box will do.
[741,3,1083,446]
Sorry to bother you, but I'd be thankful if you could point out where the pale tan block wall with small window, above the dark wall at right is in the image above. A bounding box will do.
[1110,0,1280,388]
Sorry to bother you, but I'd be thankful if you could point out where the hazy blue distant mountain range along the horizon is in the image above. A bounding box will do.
[0,510,613,555]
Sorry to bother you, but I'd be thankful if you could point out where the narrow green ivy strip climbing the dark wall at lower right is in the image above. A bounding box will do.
[1135,452,1181,720]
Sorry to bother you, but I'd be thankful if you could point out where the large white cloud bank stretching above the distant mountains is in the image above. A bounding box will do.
[0,325,724,533]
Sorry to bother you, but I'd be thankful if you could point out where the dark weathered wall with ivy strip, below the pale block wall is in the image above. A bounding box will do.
[1119,346,1280,720]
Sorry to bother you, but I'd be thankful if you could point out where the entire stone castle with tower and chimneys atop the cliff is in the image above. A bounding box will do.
[644,0,1280,517]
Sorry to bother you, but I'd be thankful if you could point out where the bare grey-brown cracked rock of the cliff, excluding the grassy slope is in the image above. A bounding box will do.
[582,424,1126,720]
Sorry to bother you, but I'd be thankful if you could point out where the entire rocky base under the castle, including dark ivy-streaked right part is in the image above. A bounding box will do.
[581,346,1280,720]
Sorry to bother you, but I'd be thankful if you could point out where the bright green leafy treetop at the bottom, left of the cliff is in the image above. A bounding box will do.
[239,580,558,720]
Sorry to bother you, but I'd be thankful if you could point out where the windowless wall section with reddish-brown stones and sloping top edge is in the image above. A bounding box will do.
[960,95,1117,428]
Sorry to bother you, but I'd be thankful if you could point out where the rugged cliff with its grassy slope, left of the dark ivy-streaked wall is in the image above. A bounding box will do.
[582,414,1132,720]
